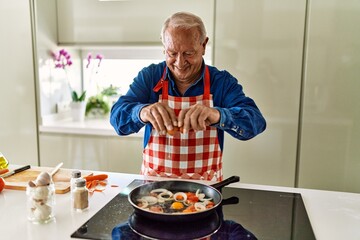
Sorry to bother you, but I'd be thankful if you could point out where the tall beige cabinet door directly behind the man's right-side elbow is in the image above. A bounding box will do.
[214,0,306,186]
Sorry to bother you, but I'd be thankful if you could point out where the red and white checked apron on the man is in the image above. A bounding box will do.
[141,66,223,181]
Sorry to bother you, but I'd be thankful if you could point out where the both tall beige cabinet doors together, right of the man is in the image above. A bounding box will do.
[214,0,360,192]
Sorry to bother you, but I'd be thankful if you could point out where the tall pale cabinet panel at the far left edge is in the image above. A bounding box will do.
[0,0,38,165]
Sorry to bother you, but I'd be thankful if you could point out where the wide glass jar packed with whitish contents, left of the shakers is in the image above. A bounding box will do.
[26,173,55,223]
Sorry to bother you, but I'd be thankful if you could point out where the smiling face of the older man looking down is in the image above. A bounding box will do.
[163,27,208,87]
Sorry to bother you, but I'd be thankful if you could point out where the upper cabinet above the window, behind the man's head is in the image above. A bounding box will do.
[57,0,214,45]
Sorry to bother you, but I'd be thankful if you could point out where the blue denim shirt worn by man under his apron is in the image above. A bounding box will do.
[110,61,266,150]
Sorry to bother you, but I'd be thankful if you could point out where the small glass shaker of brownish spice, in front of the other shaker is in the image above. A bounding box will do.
[71,178,89,212]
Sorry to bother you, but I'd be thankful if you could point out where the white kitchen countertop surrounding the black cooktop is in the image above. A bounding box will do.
[0,166,360,240]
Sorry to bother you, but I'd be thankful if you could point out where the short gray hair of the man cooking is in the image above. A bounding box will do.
[161,12,206,44]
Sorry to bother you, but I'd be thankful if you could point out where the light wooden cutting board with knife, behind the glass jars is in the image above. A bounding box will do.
[4,167,92,194]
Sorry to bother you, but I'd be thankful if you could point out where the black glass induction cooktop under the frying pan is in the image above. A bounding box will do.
[71,180,316,240]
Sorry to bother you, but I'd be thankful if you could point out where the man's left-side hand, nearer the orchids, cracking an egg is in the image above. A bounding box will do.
[140,102,178,135]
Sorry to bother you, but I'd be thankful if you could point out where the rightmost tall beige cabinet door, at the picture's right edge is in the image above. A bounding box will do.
[299,0,360,193]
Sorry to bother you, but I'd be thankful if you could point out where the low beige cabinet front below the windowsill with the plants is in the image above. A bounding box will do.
[39,133,142,174]
